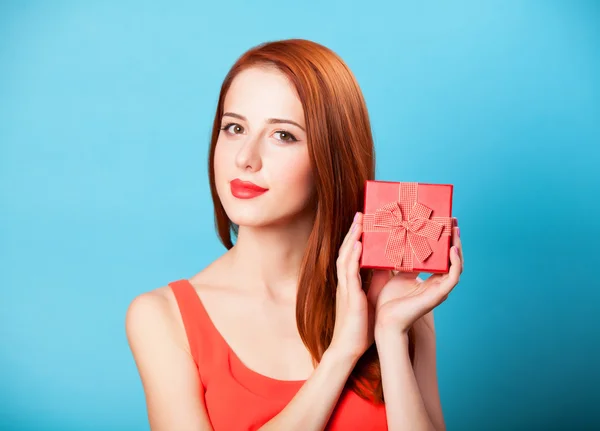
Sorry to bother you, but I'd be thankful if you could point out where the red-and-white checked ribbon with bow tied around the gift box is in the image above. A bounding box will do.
[363,183,452,272]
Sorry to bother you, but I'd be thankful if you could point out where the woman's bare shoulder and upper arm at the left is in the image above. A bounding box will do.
[125,286,211,431]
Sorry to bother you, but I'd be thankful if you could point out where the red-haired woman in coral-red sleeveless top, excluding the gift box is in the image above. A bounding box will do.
[126,40,463,431]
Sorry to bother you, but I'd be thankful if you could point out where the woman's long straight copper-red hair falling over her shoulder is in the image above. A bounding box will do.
[208,39,414,402]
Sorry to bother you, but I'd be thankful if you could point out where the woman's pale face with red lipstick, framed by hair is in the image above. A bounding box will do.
[214,67,314,230]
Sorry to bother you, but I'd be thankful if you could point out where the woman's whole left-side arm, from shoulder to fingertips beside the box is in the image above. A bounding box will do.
[126,214,373,431]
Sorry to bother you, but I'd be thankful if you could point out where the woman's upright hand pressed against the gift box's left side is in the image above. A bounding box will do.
[327,213,374,361]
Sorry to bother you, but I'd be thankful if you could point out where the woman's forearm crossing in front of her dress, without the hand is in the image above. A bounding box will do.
[260,350,356,431]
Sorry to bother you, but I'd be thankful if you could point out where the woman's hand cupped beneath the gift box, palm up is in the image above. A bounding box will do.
[367,223,464,335]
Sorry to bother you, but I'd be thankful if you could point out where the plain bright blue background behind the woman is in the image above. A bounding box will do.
[0,0,600,431]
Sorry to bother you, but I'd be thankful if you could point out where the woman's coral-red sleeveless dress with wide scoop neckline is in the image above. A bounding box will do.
[169,280,387,431]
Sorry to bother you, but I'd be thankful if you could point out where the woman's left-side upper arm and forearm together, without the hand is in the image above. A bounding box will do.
[126,292,356,431]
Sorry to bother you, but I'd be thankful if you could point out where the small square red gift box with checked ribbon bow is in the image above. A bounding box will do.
[360,181,456,273]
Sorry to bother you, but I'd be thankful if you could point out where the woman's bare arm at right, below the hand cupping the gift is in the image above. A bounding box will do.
[375,311,446,431]
